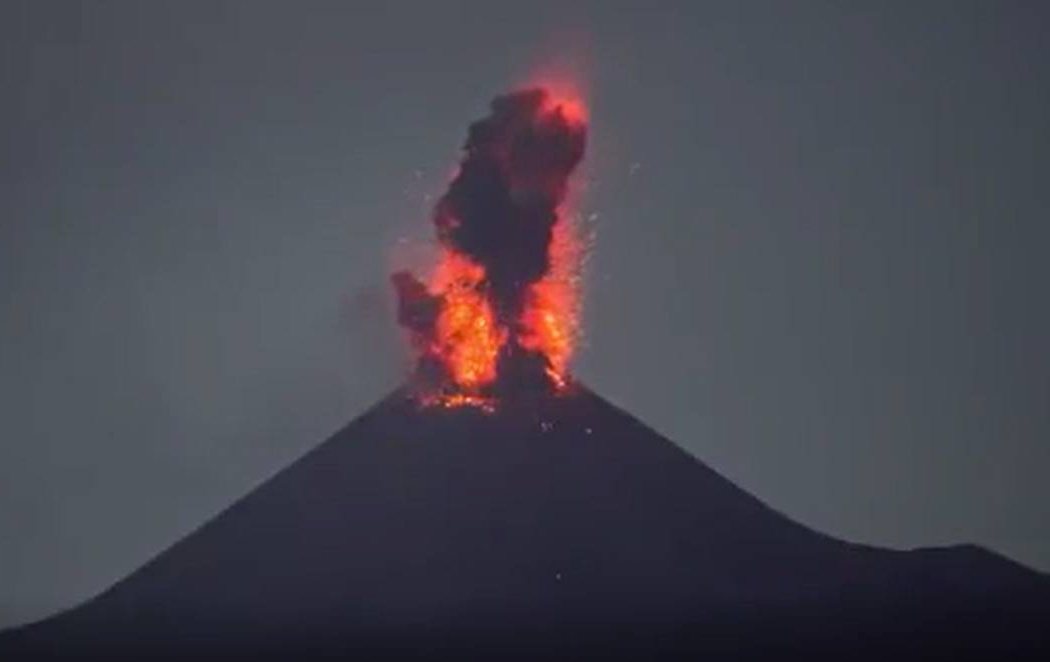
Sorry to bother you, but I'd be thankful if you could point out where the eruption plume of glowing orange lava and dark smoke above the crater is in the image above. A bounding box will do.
[393,87,587,408]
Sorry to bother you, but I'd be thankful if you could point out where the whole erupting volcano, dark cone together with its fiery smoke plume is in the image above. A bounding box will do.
[0,89,1050,662]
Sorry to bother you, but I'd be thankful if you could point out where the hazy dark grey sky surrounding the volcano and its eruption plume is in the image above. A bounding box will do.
[0,0,1050,627]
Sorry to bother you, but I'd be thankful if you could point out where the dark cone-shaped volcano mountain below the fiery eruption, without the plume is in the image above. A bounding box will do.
[0,386,1050,660]
